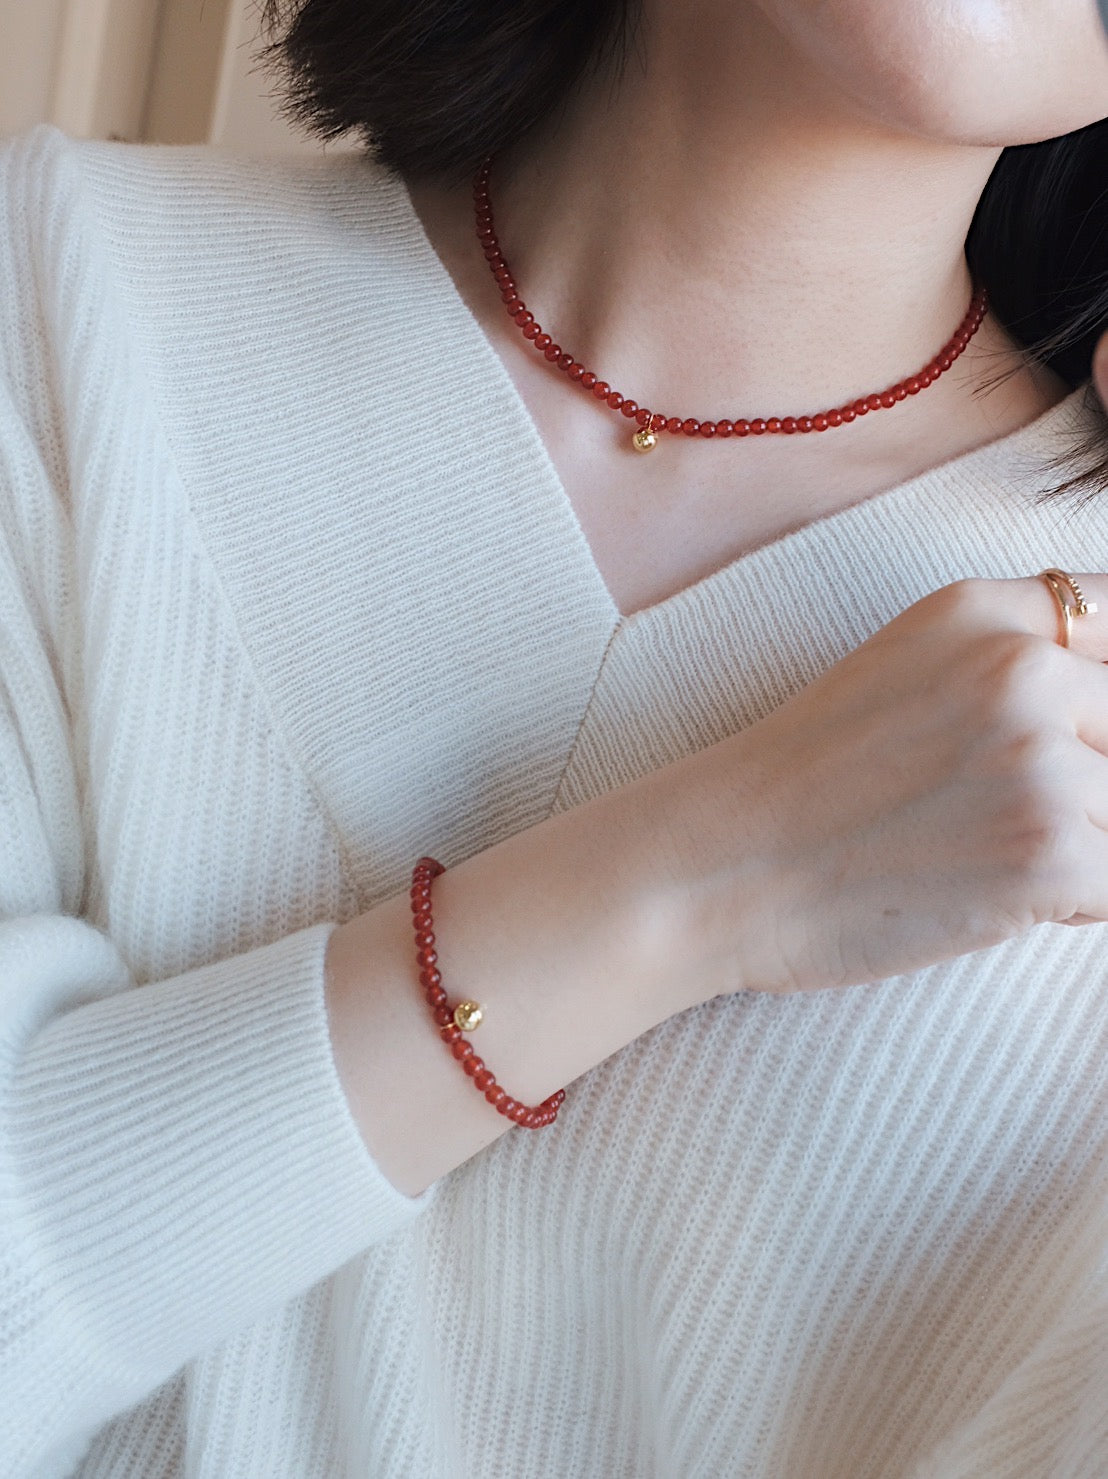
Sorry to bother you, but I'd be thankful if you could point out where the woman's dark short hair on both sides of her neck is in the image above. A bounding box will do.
[263,0,1108,493]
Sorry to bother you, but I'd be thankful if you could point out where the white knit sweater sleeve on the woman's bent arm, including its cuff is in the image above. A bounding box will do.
[0,130,435,1479]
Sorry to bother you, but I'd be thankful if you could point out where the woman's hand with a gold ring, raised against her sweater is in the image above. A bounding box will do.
[675,574,1108,991]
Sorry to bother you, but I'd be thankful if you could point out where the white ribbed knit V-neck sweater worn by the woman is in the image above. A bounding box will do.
[0,121,1108,1479]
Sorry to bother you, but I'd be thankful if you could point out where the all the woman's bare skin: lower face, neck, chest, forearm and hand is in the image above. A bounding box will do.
[327,0,1108,1194]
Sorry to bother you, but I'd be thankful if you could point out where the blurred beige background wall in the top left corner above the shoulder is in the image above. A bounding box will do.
[0,0,334,154]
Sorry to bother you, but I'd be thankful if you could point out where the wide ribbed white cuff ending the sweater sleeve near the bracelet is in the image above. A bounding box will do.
[12,918,436,1392]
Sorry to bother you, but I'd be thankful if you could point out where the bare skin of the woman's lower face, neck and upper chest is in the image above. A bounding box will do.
[413,0,1108,614]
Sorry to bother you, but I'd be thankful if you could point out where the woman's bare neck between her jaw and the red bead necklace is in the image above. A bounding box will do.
[479,4,1041,419]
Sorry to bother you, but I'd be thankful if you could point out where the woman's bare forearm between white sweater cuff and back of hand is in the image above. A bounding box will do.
[327,751,730,1195]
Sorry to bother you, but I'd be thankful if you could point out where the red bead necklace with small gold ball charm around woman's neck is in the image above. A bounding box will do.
[473,158,988,453]
